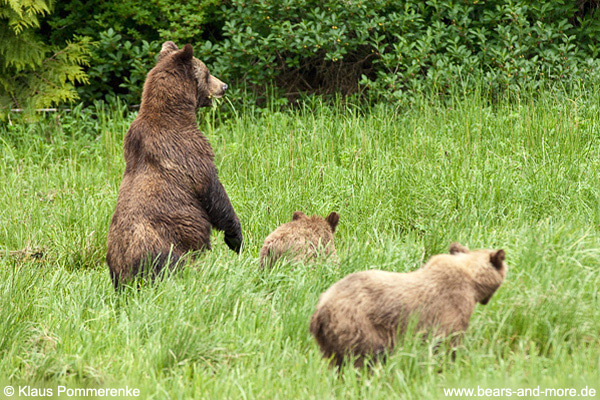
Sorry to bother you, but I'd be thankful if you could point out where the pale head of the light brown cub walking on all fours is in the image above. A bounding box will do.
[450,243,508,304]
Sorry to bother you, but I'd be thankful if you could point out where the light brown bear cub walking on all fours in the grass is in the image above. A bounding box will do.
[310,243,508,368]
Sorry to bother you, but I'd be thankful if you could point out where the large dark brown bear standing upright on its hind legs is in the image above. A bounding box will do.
[106,41,242,288]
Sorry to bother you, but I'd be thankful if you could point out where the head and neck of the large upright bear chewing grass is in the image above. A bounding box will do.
[141,41,227,111]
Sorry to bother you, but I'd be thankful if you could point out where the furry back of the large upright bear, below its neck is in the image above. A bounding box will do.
[107,113,214,278]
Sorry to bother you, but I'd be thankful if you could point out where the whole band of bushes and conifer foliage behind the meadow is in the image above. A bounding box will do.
[0,0,600,108]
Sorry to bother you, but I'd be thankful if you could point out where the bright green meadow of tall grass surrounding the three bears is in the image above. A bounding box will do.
[0,90,600,399]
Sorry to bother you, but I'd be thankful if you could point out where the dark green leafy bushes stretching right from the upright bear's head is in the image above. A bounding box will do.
[201,0,600,100]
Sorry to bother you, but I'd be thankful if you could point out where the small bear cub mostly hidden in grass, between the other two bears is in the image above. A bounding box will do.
[260,211,340,268]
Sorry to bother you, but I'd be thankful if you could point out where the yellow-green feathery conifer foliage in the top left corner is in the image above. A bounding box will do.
[0,0,90,119]
